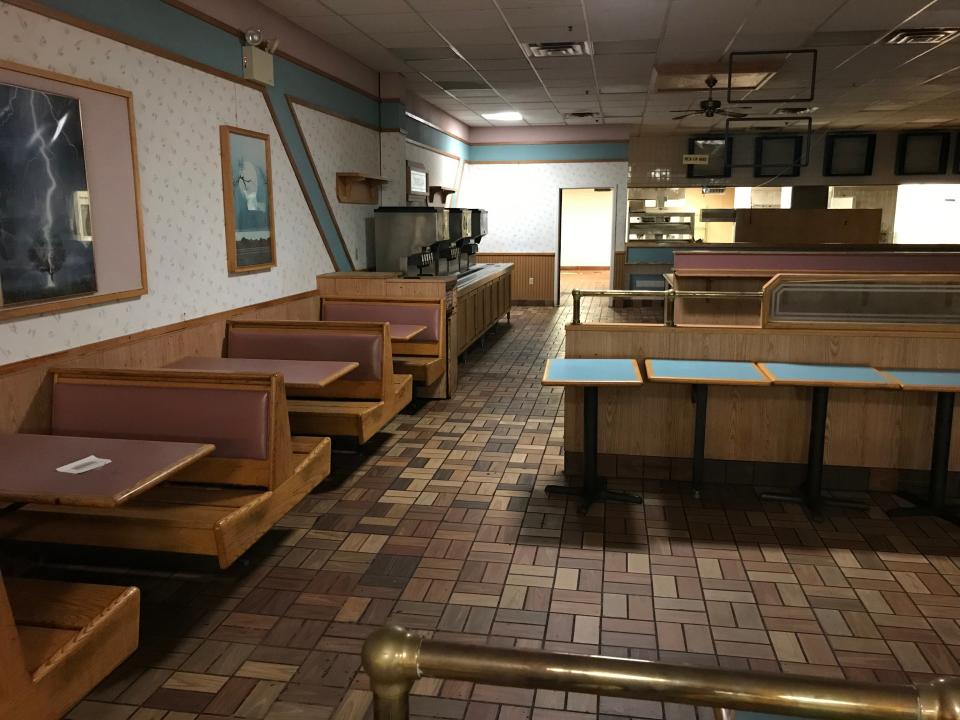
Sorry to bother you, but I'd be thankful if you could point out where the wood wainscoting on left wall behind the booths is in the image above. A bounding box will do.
[0,290,320,433]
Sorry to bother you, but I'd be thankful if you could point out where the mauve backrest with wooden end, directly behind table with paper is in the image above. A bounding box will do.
[52,369,292,489]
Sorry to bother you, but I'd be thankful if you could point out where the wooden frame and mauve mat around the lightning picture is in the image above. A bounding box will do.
[0,60,148,322]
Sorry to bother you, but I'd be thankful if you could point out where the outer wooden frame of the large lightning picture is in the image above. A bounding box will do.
[0,60,148,322]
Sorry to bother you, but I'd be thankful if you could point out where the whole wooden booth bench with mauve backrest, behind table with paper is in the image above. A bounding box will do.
[0,368,330,568]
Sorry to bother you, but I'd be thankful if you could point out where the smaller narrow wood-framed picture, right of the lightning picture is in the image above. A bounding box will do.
[220,125,277,273]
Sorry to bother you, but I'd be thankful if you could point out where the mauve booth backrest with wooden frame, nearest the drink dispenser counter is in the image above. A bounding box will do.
[320,298,446,357]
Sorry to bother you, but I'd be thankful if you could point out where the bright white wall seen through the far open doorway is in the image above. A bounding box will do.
[560,188,615,267]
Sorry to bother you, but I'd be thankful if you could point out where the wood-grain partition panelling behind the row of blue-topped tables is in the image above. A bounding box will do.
[565,324,960,470]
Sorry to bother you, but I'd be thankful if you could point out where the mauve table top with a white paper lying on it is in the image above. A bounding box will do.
[0,433,214,507]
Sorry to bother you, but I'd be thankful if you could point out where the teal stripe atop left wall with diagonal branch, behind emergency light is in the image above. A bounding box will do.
[30,0,368,270]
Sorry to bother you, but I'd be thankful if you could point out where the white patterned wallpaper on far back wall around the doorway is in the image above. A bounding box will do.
[457,162,627,253]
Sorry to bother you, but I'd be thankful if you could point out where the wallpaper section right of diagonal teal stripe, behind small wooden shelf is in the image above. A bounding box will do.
[294,104,380,269]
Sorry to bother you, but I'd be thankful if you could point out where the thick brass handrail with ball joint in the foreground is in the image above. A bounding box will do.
[363,626,960,720]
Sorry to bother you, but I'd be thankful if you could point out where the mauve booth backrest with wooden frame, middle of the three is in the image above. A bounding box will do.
[226,320,393,400]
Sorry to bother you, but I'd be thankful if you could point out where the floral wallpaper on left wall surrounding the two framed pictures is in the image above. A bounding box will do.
[0,3,338,364]
